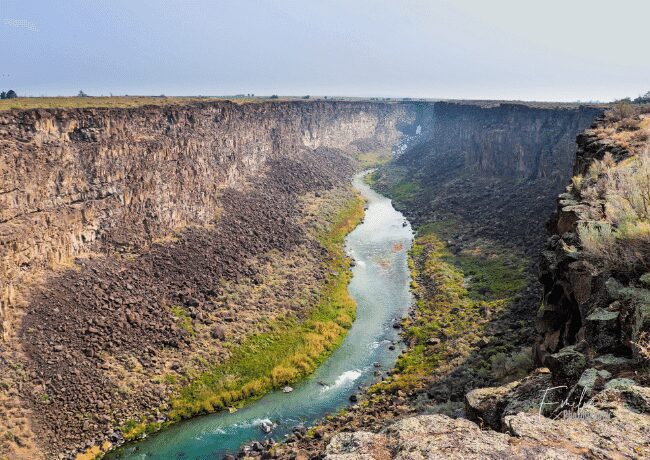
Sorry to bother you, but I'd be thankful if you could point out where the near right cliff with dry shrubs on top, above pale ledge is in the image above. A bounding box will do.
[536,116,650,371]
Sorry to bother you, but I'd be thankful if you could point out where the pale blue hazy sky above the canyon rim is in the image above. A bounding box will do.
[0,0,650,100]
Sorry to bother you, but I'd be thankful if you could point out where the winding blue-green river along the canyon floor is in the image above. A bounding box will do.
[109,173,412,460]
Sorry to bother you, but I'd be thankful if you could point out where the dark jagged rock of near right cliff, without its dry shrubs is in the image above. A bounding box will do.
[535,119,650,370]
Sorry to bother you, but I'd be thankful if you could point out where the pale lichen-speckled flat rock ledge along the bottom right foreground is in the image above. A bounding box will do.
[325,408,650,460]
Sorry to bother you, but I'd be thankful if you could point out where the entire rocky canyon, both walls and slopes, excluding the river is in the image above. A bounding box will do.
[0,100,650,459]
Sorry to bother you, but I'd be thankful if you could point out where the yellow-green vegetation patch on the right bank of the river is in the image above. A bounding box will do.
[371,220,530,393]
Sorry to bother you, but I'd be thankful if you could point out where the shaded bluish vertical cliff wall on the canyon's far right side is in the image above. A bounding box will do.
[398,102,601,181]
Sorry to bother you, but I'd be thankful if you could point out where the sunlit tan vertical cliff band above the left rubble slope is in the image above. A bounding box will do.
[0,102,409,337]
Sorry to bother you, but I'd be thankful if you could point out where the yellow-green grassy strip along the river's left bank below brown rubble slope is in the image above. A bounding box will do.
[122,192,364,440]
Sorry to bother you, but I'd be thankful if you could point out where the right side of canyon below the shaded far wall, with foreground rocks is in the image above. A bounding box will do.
[270,107,650,460]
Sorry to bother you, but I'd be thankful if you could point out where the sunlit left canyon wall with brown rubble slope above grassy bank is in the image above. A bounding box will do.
[0,101,414,458]
